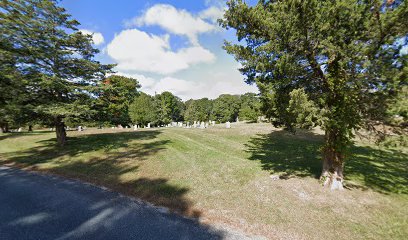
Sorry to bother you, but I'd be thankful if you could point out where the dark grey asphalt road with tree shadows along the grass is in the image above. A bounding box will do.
[0,166,246,240]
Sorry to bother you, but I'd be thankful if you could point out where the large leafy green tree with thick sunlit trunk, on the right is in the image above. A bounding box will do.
[220,0,408,189]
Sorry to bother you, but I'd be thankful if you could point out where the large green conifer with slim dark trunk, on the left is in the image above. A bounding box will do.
[0,0,113,145]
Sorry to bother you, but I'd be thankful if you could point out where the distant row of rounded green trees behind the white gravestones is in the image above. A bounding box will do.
[129,92,261,125]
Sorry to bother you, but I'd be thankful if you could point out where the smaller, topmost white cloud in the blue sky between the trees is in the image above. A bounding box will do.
[128,4,216,45]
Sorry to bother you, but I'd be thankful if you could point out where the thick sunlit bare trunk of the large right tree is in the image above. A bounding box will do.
[320,130,344,190]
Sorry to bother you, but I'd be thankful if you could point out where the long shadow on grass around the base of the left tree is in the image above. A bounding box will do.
[4,131,169,166]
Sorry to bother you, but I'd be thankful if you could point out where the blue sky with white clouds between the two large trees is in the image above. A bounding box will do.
[61,0,257,100]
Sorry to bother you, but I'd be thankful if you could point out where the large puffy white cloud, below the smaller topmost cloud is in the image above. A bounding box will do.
[106,29,215,74]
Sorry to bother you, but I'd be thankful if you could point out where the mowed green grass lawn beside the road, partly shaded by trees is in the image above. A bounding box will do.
[0,124,408,239]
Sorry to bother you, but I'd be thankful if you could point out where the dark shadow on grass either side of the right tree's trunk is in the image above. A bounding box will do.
[246,130,408,194]
